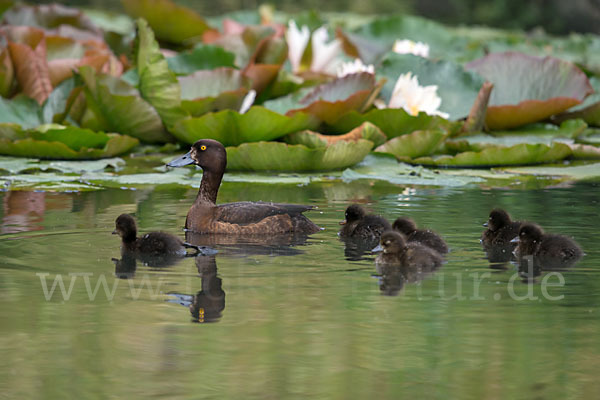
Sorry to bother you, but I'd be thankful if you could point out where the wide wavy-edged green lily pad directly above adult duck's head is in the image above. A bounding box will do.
[173,106,319,146]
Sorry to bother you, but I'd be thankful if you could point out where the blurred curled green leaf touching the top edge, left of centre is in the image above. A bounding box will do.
[121,0,213,43]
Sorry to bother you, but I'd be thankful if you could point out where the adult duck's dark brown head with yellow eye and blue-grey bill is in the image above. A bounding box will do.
[167,139,227,172]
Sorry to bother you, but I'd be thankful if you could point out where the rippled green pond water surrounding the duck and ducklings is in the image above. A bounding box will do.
[0,180,600,399]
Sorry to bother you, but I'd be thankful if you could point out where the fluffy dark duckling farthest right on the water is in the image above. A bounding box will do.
[512,222,584,268]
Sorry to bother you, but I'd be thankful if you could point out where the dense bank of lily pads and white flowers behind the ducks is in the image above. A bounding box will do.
[0,0,600,177]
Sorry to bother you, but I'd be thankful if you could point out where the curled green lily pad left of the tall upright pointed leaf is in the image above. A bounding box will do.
[79,67,173,143]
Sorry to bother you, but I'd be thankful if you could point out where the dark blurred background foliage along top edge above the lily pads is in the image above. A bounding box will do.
[39,0,600,34]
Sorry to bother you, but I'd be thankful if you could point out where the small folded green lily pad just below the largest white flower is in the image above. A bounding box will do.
[375,130,448,159]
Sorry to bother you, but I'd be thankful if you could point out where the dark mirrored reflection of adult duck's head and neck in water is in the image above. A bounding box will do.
[167,255,225,323]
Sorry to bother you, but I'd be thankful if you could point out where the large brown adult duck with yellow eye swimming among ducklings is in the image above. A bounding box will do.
[167,139,321,235]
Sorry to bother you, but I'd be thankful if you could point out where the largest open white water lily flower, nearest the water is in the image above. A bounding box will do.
[388,72,450,118]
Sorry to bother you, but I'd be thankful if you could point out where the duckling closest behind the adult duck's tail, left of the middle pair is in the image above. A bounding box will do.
[339,204,392,241]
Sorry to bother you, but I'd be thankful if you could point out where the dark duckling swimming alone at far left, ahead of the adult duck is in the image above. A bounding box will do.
[112,214,216,257]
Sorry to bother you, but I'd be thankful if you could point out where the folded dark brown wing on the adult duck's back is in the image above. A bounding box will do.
[216,201,313,225]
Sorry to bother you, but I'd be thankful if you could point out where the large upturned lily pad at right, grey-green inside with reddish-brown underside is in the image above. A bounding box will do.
[466,52,593,129]
